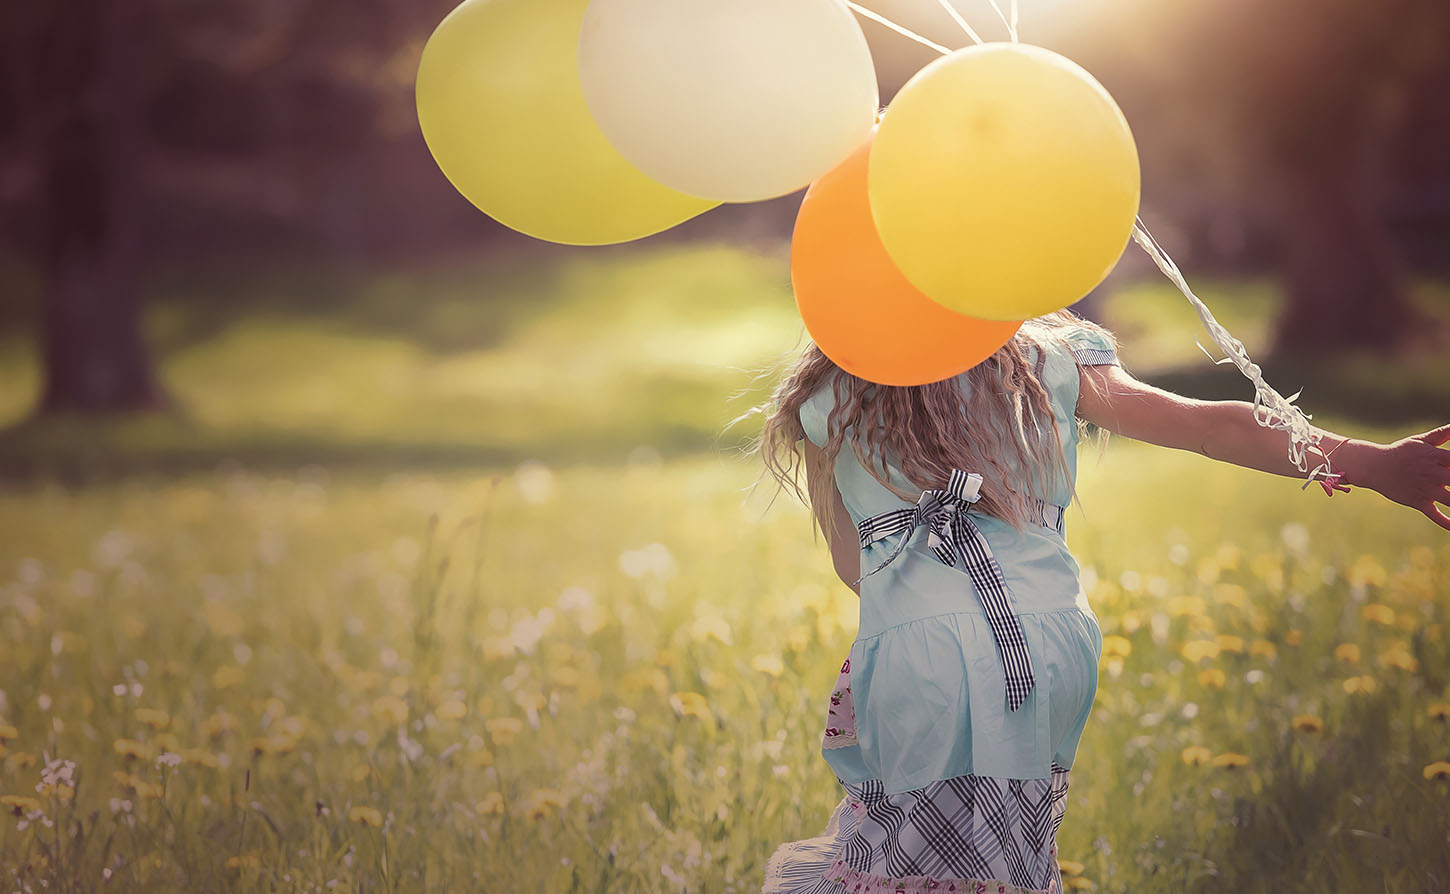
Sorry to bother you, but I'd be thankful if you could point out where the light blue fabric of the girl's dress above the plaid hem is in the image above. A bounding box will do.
[800,327,1117,795]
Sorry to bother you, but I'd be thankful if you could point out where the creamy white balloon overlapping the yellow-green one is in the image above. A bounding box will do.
[580,0,880,201]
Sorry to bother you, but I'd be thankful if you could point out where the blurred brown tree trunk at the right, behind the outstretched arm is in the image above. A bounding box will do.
[1177,0,1450,356]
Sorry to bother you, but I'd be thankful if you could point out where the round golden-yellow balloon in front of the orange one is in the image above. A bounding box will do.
[869,43,1141,320]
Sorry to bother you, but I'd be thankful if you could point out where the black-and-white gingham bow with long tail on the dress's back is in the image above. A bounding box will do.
[857,469,1038,711]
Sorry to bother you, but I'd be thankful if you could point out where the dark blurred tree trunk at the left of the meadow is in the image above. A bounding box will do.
[32,0,162,413]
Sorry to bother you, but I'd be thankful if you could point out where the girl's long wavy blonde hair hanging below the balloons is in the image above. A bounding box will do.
[753,310,1115,544]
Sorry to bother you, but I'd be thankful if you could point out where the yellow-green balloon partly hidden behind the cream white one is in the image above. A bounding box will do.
[418,0,718,245]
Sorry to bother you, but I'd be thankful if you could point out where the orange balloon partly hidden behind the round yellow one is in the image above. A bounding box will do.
[790,135,1022,385]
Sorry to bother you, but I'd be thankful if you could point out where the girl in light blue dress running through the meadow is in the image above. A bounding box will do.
[760,310,1450,894]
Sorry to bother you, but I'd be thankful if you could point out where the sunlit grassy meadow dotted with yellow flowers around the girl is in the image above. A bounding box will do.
[0,240,1450,894]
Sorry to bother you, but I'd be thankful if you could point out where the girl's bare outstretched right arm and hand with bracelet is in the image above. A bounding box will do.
[1077,365,1450,530]
